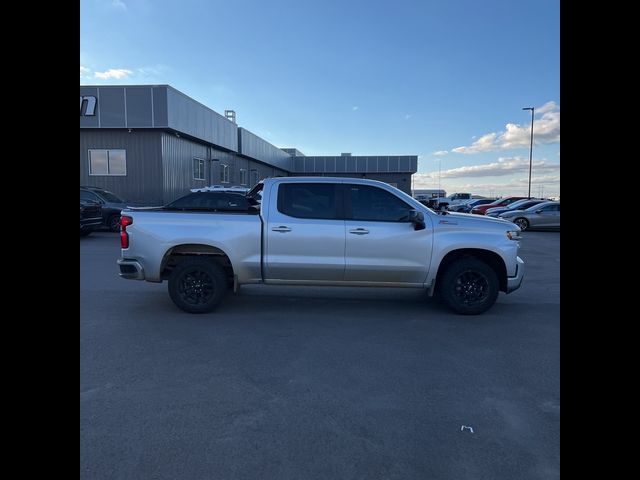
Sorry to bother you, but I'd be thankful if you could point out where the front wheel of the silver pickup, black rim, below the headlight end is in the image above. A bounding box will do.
[439,258,499,315]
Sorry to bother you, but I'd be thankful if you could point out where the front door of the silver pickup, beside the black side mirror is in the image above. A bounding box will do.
[345,184,433,284]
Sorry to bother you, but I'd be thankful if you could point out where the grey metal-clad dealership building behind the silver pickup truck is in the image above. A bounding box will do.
[80,85,417,205]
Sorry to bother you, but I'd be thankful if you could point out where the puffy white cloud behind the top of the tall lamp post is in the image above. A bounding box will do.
[451,102,560,153]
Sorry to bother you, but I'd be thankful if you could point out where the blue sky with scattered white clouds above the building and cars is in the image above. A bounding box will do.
[80,0,560,197]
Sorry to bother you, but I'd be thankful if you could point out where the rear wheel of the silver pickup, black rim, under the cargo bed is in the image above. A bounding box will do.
[169,258,227,313]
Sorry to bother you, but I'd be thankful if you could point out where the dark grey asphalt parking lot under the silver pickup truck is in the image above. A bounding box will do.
[80,232,560,480]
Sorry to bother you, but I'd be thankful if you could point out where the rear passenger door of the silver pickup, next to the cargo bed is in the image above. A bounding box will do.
[265,182,345,282]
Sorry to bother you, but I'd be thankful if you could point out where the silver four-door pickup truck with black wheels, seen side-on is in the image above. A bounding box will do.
[118,177,524,315]
